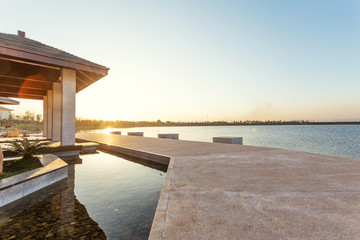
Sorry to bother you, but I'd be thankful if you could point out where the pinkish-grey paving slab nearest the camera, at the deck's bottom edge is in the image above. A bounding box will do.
[162,191,360,240]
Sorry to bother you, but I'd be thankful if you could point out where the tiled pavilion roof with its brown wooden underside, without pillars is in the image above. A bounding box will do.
[0,31,109,99]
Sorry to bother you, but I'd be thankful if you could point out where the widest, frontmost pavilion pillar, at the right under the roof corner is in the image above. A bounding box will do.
[61,68,76,146]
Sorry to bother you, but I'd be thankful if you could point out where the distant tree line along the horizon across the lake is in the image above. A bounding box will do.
[76,118,360,130]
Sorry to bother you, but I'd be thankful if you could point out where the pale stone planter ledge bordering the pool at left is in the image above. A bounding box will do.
[0,154,68,207]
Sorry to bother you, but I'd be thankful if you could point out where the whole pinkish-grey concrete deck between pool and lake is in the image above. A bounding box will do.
[77,133,360,239]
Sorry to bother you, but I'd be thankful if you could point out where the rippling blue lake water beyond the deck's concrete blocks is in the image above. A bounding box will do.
[92,125,360,159]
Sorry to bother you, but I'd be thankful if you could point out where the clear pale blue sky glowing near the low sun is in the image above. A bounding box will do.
[0,0,360,121]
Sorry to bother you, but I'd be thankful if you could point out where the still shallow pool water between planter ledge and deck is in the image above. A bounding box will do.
[0,152,166,239]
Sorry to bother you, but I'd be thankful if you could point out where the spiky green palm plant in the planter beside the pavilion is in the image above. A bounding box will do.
[11,138,46,159]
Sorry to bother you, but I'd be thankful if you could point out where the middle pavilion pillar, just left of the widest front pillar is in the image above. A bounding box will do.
[52,83,62,142]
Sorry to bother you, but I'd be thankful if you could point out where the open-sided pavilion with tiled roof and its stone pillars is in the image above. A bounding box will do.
[0,31,109,146]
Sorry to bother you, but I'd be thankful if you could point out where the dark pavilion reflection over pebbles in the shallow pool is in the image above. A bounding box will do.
[0,165,106,239]
